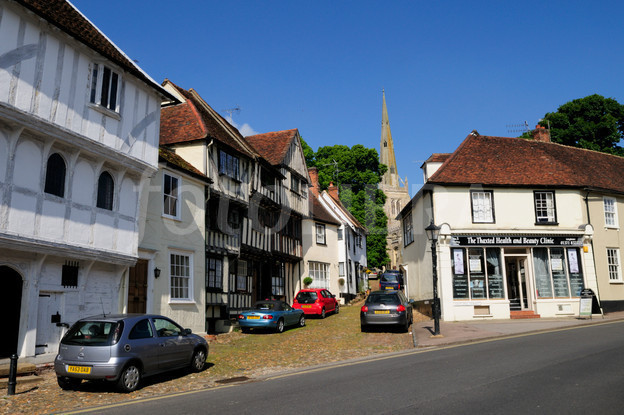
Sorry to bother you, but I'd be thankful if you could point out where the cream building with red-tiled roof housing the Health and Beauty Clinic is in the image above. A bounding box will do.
[399,131,612,321]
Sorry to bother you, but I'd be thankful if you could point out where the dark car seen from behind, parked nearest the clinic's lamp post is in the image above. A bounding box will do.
[360,290,414,332]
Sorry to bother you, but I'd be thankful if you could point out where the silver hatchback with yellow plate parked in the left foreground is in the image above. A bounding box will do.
[54,314,208,392]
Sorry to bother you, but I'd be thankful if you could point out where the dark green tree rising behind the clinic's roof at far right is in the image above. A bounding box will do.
[540,94,624,156]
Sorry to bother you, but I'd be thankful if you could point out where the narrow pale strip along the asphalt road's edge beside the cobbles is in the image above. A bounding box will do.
[62,320,624,414]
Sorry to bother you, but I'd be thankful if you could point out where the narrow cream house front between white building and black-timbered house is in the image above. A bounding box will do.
[139,162,208,332]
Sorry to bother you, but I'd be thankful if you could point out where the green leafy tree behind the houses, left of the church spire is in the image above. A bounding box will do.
[302,142,389,267]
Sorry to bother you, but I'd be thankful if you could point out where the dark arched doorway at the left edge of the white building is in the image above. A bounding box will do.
[0,266,22,358]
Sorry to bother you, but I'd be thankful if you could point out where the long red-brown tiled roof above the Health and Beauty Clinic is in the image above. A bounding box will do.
[429,132,624,193]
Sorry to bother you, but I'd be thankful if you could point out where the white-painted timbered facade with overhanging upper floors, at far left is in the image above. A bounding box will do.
[0,1,163,357]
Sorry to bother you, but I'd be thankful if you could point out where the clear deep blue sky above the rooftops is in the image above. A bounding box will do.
[73,0,624,195]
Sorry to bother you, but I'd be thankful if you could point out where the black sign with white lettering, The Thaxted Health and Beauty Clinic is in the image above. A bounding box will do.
[451,235,583,246]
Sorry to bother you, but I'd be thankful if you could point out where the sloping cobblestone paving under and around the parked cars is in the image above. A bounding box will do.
[0,303,428,414]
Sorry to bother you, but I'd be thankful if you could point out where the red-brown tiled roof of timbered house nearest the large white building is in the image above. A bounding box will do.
[160,81,257,158]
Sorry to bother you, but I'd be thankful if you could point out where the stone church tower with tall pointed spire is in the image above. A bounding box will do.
[379,90,410,269]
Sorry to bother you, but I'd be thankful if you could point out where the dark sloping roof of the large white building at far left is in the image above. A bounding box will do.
[15,0,173,98]
